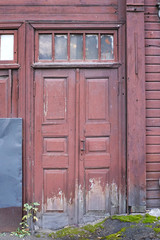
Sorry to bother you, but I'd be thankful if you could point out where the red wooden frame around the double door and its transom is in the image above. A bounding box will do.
[24,22,126,217]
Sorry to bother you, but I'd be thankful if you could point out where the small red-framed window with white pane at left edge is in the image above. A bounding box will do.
[0,30,17,63]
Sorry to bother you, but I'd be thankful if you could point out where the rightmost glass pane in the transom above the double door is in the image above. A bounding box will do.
[101,35,114,60]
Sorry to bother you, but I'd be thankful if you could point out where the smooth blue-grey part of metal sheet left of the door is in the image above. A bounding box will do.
[0,118,22,208]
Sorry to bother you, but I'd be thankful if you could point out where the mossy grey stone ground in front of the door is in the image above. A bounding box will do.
[0,214,160,240]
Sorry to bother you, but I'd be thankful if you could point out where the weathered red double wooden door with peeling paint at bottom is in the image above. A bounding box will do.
[34,69,120,229]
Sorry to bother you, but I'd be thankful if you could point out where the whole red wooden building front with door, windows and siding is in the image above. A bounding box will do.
[0,0,160,232]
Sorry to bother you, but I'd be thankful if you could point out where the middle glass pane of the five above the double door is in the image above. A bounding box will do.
[70,34,83,59]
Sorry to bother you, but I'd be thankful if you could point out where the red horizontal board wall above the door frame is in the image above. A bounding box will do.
[0,0,123,22]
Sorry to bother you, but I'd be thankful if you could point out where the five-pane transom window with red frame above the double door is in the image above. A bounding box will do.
[35,31,117,62]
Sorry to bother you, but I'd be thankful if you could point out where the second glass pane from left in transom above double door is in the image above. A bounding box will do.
[55,34,67,60]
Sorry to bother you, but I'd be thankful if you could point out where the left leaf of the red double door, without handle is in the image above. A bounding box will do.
[35,70,75,228]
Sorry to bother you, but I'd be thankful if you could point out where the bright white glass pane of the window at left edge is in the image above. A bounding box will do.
[0,34,14,61]
